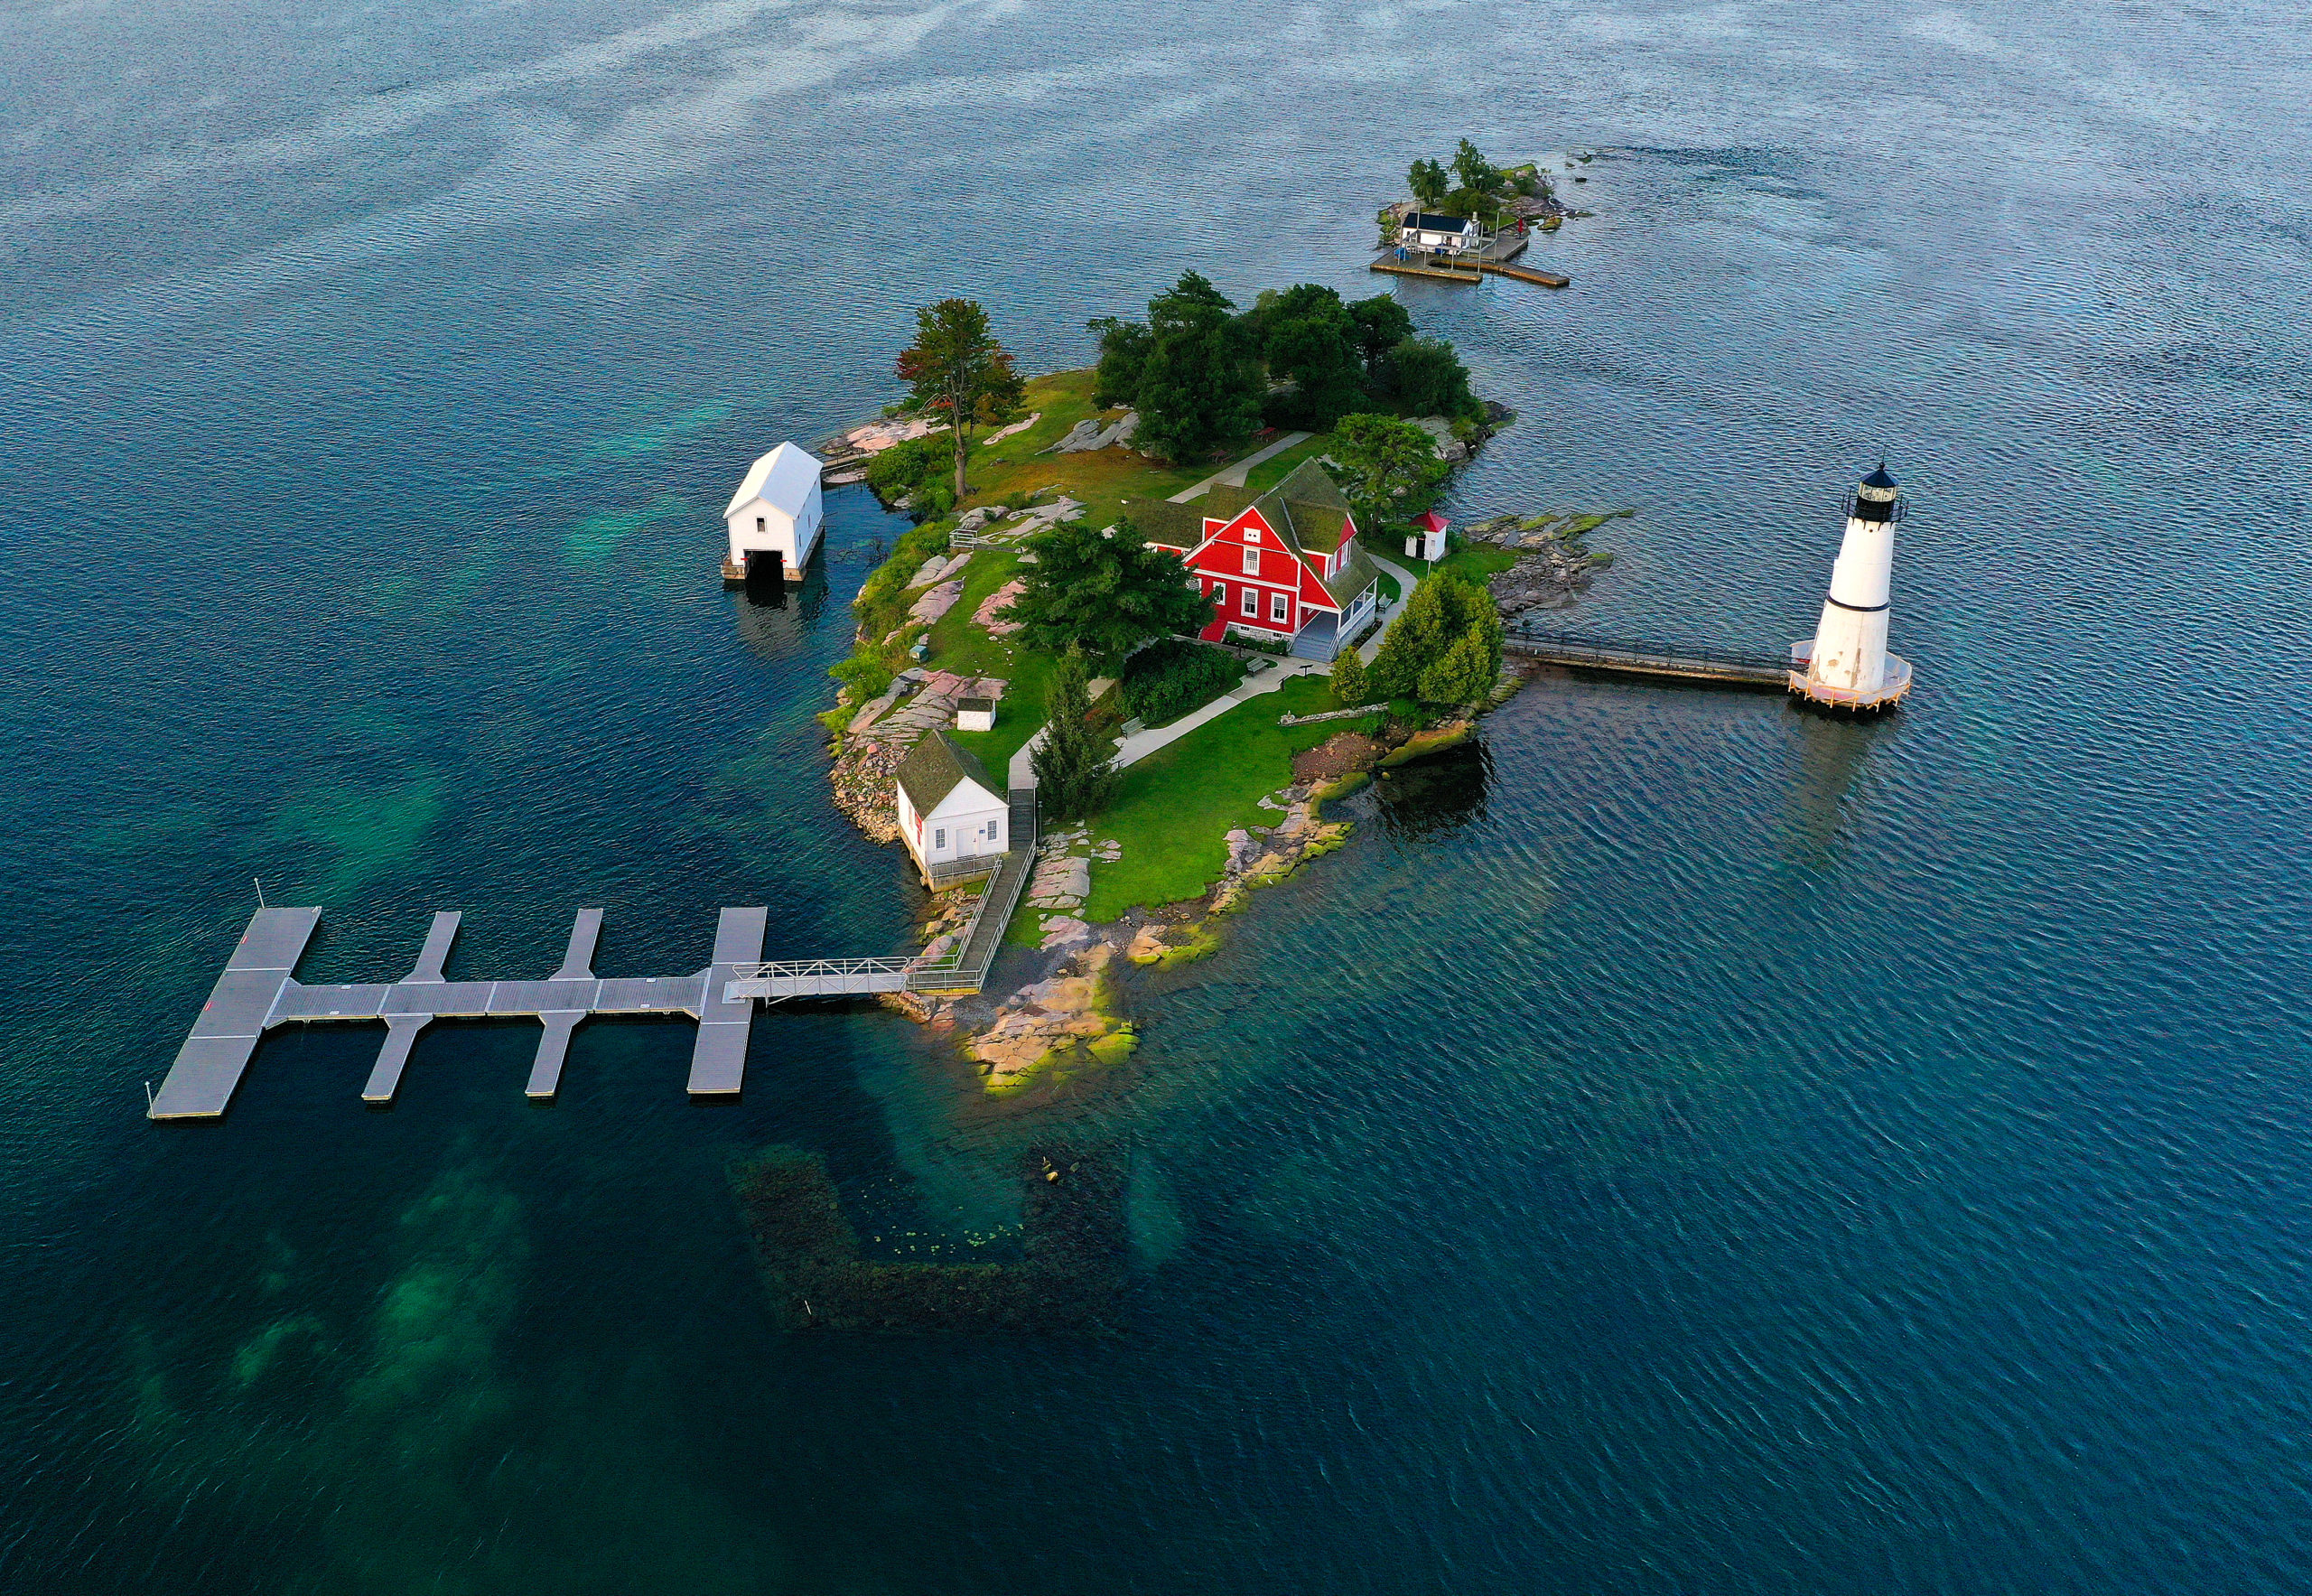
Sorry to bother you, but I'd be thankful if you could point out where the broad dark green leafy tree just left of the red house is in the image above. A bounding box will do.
[1011,509,1211,668]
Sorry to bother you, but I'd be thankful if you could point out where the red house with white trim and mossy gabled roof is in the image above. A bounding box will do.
[1133,461,1380,659]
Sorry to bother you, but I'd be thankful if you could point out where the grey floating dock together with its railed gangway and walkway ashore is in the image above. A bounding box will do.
[145,787,1036,1119]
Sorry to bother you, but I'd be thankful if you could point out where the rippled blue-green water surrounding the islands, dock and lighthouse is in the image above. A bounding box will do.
[0,0,2312,1596]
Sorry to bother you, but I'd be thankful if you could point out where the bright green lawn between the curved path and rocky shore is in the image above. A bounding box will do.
[1082,676,1380,920]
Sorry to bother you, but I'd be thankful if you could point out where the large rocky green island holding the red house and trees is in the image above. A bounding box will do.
[821,271,1636,1094]
